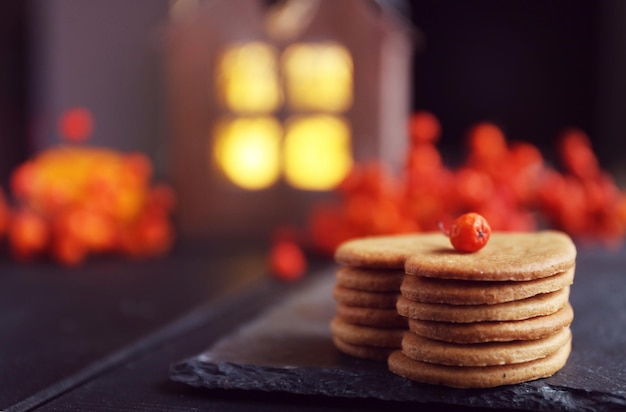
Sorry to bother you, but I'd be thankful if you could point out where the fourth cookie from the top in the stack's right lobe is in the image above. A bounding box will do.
[409,303,574,343]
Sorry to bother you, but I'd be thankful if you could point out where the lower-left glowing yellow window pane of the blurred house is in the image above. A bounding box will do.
[214,117,282,190]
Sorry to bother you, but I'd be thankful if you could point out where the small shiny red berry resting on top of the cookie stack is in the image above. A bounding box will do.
[444,213,491,252]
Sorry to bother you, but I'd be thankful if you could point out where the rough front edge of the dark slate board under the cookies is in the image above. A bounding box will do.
[170,355,626,411]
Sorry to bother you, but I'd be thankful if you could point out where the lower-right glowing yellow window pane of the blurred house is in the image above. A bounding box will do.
[283,115,352,190]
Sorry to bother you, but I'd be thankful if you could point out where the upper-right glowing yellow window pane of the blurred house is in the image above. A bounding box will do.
[283,43,353,112]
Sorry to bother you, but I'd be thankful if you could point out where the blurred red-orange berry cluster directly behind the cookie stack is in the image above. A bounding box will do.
[308,111,626,253]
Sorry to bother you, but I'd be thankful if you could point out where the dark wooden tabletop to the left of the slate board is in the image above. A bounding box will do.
[0,241,286,411]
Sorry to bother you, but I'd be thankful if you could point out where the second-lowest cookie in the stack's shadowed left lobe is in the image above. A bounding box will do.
[330,317,406,348]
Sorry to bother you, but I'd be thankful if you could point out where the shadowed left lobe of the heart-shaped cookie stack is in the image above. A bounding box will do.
[330,236,416,361]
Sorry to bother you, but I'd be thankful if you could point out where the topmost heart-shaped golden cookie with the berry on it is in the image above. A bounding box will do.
[335,231,576,281]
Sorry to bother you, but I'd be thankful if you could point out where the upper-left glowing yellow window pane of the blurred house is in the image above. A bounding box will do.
[216,42,282,113]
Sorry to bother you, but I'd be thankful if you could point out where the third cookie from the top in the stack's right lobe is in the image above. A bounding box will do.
[397,286,569,323]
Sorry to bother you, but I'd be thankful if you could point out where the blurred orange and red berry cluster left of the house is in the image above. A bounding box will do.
[0,146,175,265]
